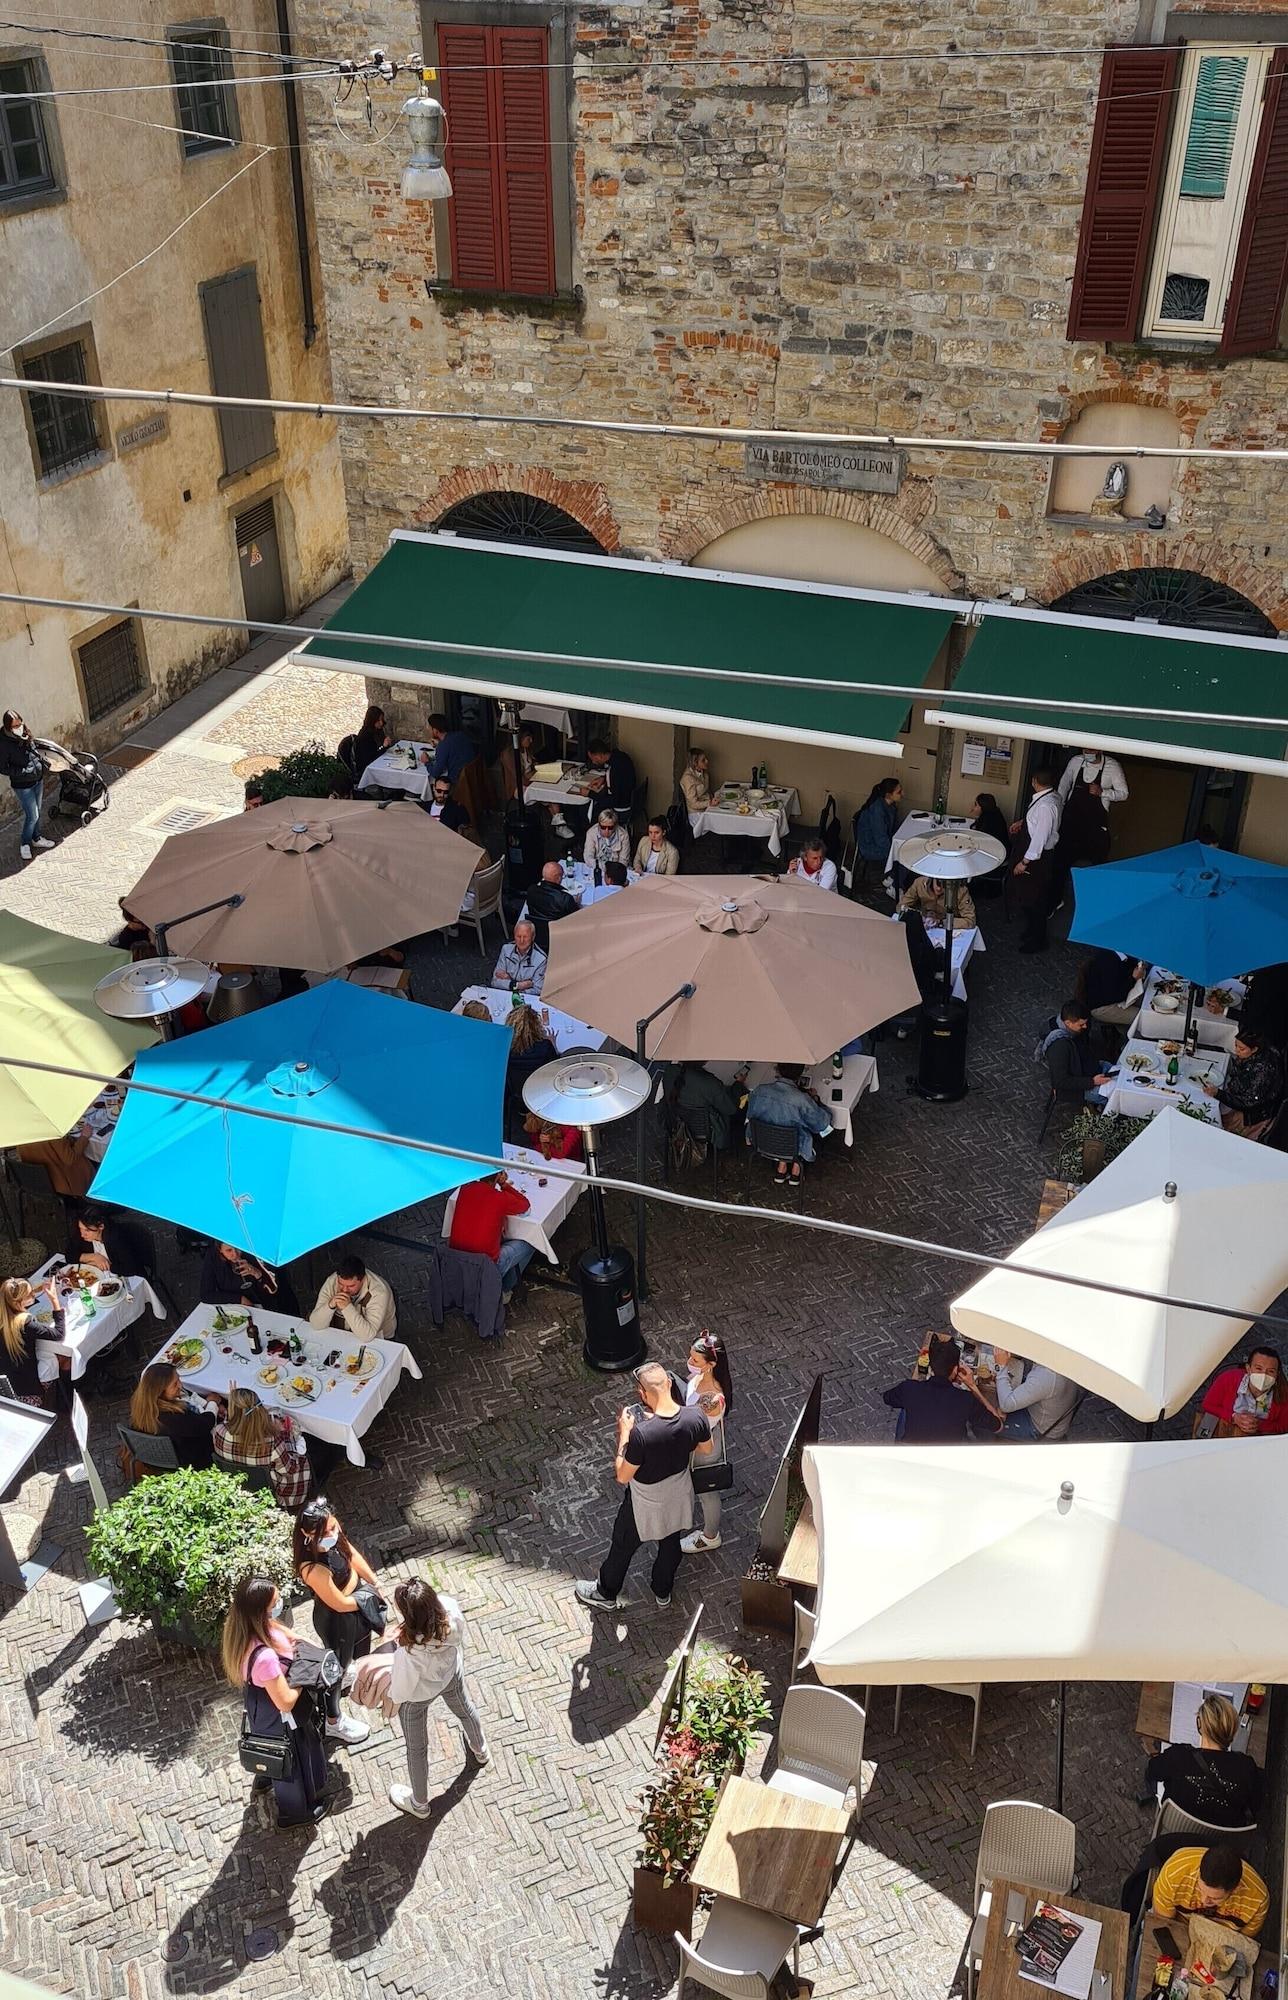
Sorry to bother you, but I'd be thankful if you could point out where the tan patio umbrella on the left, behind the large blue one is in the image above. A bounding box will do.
[126,798,478,972]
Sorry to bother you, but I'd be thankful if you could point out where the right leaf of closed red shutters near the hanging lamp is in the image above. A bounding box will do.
[492,28,554,294]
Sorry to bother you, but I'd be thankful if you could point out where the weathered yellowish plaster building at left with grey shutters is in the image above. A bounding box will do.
[0,0,348,752]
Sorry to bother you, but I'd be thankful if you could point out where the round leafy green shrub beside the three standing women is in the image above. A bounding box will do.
[86,1466,292,1646]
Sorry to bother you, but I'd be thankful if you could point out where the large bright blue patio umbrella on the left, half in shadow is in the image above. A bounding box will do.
[92,980,510,1264]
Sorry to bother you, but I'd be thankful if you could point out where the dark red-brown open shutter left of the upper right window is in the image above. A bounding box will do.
[1068,48,1180,340]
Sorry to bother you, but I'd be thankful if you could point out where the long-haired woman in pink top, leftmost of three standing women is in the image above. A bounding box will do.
[220,1576,330,1826]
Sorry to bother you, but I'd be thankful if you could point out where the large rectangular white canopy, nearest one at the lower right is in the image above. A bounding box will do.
[804,1438,1288,1686]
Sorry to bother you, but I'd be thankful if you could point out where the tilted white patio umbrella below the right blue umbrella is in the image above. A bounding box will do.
[950,1108,1288,1424]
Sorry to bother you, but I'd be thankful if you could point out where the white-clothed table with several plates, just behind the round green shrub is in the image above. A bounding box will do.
[152,1306,420,1466]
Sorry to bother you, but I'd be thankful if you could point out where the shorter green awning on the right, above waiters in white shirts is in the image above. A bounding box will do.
[930,612,1288,778]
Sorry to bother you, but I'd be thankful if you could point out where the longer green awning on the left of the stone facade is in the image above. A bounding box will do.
[298,532,966,758]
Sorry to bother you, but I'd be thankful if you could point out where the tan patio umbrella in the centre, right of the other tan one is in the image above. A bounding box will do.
[542,876,920,1064]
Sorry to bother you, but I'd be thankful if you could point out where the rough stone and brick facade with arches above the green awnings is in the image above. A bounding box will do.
[296,0,1288,858]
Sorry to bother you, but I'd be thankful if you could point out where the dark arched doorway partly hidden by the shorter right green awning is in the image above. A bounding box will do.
[1034,568,1276,860]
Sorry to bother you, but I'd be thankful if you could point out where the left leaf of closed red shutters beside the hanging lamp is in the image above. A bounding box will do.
[438,24,504,292]
